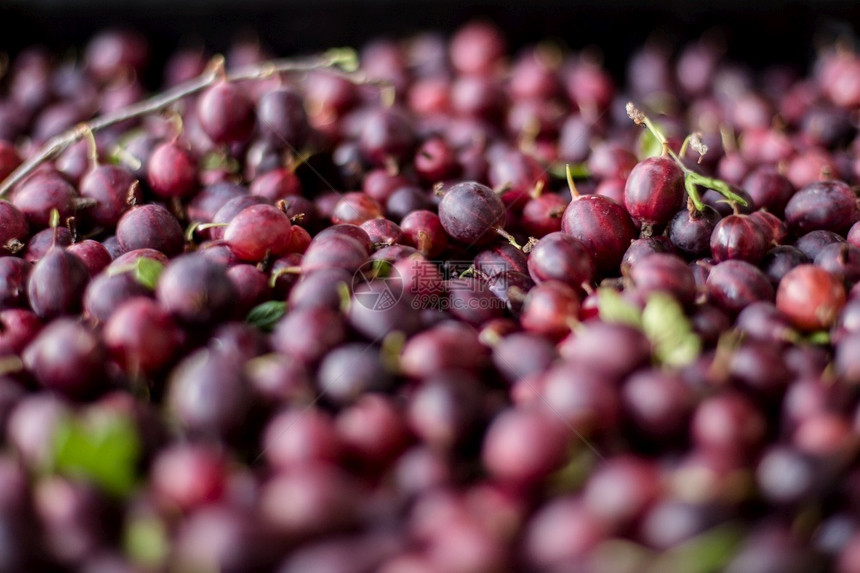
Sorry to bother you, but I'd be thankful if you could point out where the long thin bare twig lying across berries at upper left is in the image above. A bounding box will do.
[0,48,357,197]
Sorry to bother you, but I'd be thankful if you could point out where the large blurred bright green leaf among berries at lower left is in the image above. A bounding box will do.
[52,413,140,496]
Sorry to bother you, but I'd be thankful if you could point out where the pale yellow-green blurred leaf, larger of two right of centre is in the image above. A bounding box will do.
[642,293,702,366]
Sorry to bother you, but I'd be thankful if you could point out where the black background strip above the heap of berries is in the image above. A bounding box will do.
[0,0,860,80]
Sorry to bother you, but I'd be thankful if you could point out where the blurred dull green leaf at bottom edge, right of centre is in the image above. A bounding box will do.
[647,523,743,573]
